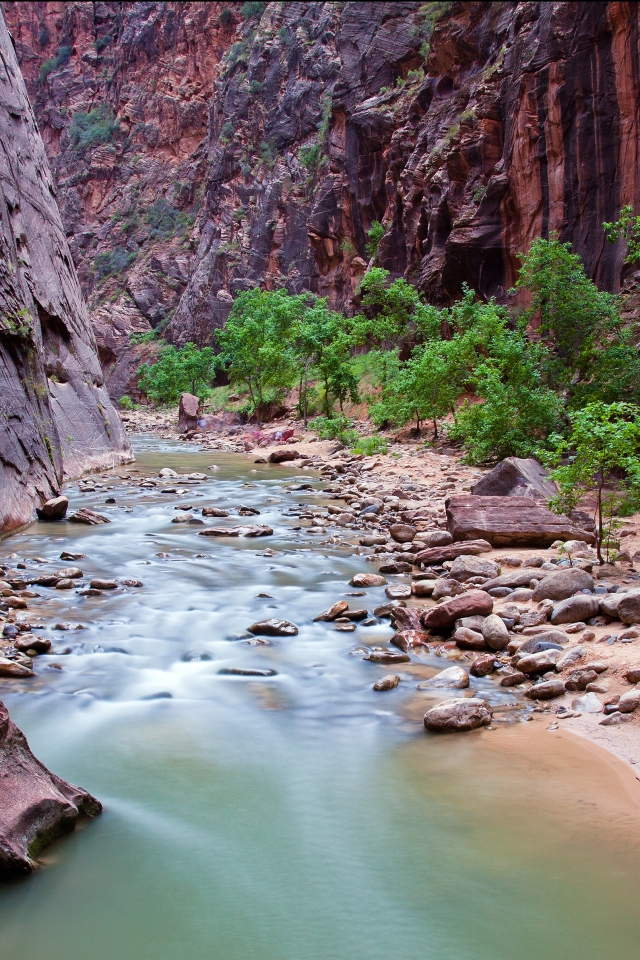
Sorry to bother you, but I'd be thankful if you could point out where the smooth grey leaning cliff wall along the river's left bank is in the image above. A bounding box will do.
[0,9,131,533]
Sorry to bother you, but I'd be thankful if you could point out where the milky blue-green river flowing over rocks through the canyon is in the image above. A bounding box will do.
[0,442,640,960]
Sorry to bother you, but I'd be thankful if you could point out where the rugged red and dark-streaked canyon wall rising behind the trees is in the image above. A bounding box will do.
[6,2,640,368]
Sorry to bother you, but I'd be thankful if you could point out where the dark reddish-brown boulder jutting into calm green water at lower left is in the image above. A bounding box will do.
[0,703,102,880]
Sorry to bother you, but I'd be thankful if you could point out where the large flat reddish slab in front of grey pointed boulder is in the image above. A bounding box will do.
[444,496,594,559]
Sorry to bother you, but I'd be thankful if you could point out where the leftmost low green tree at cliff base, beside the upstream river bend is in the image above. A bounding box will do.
[138,343,218,404]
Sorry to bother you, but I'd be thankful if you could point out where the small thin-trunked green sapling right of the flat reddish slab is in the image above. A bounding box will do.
[548,402,640,563]
